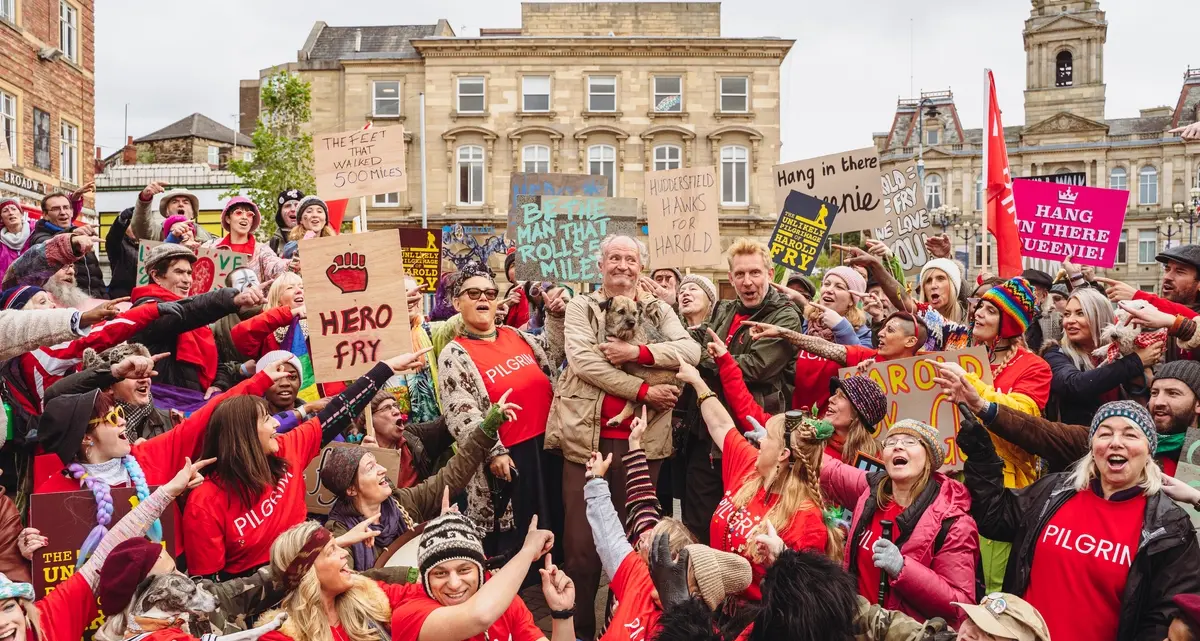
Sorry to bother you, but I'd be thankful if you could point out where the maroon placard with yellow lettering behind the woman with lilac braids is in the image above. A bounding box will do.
[29,486,176,600]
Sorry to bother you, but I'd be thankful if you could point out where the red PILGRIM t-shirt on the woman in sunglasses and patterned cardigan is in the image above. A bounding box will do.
[455,327,554,448]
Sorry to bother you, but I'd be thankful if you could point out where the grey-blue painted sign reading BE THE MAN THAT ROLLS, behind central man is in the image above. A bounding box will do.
[508,196,637,282]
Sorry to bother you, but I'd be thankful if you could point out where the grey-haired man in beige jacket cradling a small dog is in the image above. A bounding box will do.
[546,236,700,639]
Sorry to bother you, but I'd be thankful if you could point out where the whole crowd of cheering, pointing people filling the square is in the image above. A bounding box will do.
[0,166,1200,641]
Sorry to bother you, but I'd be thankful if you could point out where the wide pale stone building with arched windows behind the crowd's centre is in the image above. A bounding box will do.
[241,2,793,283]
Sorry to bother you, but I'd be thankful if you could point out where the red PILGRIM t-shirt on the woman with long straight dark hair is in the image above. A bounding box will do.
[181,418,320,575]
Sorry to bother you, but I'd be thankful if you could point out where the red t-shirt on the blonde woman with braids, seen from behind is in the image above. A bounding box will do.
[708,430,829,600]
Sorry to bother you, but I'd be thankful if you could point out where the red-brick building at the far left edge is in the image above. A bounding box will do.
[0,0,96,215]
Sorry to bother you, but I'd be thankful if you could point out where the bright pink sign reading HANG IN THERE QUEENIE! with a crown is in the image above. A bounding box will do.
[1013,180,1129,269]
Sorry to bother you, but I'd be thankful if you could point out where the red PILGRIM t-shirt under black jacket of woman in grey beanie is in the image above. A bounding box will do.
[1025,490,1146,641]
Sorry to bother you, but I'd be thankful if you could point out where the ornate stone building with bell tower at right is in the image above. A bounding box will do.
[874,0,1200,289]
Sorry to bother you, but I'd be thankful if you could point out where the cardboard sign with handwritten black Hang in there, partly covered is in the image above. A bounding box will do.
[775,146,884,234]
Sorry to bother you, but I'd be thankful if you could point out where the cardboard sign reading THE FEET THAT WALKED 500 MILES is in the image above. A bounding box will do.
[312,125,408,200]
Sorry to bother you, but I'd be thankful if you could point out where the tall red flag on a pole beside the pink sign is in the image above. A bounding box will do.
[984,71,1021,278]
